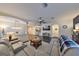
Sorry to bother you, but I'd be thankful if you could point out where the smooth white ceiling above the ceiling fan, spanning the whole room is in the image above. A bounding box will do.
[0,3,79,20]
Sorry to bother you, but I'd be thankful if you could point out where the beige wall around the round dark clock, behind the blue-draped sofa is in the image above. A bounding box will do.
[52,11,78,36]
